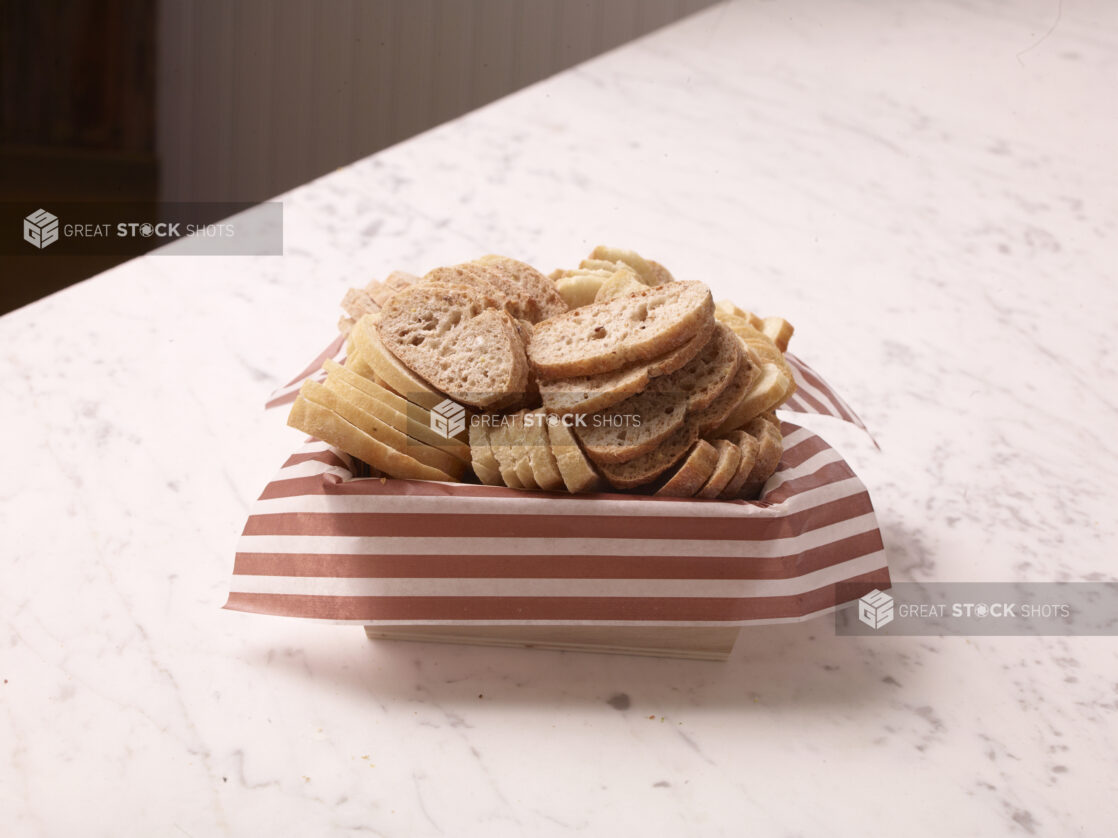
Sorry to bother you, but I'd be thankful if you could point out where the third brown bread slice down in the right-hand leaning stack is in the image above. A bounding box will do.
[577,324,743,464]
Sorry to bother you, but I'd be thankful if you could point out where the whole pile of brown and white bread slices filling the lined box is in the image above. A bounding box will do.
[288,247,795,498]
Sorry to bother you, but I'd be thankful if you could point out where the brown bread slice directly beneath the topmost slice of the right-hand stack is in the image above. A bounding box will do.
[539,321,714,415]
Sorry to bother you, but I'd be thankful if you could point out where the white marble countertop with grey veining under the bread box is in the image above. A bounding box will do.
[0,0,1118,836]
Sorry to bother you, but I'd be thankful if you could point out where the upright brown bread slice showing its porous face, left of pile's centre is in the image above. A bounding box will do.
[377,284,528,408]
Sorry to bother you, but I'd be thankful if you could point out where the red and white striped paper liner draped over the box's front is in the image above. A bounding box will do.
[226,422,889,626]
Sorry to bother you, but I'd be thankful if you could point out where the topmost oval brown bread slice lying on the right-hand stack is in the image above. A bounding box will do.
[528,283,714,380]
